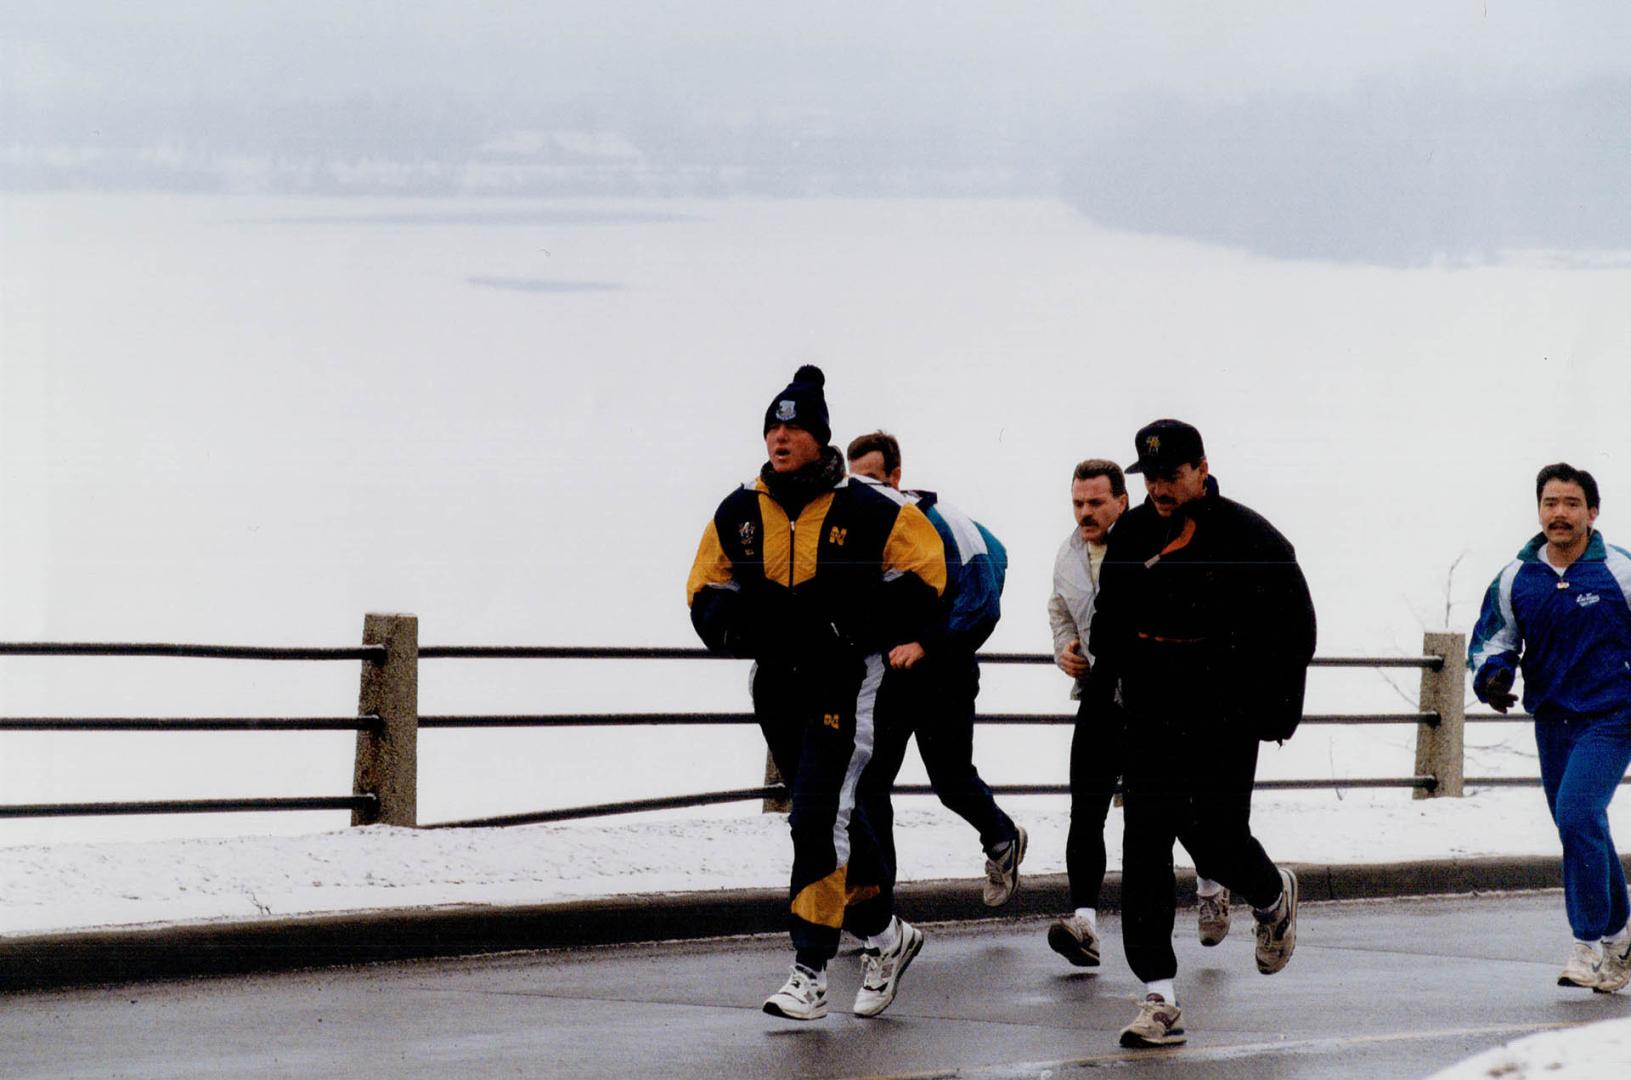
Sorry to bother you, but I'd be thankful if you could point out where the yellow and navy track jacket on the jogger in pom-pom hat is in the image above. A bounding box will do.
[687,478,946,662]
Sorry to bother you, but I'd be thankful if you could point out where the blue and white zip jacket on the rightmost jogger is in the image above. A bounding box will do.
[1466,530,1631,716]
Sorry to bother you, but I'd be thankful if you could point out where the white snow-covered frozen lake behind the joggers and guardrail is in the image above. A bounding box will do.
[0,193,1631,843]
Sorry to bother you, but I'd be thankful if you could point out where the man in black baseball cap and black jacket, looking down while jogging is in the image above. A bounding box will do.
[1085,419,1315,1046]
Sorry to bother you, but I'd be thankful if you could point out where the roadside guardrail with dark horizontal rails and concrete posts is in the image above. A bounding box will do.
[0,615,1565,829]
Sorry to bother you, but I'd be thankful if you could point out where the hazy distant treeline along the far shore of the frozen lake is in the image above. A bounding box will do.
[9,82,1631,264]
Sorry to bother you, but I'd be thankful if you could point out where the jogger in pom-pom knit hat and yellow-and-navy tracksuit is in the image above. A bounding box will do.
[687,365,946,1020]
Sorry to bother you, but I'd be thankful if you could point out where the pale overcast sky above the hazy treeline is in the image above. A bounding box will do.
[9,0,1631,109]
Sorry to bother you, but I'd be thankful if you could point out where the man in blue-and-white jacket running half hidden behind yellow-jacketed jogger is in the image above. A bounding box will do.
[848,431,1026,907]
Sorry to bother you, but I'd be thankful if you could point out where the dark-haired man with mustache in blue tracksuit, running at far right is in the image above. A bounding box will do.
[1466,463,1631,994]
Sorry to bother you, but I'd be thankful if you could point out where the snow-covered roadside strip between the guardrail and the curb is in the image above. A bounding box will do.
[0,788,1631,953]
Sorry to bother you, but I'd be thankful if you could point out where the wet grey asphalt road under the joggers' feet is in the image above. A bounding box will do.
[0,892,1631,1080]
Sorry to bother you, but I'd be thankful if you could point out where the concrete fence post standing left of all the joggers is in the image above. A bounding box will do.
[351,615,419,827]
